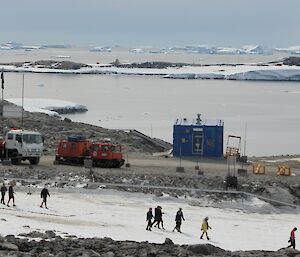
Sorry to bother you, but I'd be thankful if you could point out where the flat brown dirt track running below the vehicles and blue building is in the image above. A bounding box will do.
[0,153,300,189]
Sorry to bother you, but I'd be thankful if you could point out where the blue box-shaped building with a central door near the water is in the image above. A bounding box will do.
[173,114,224,157]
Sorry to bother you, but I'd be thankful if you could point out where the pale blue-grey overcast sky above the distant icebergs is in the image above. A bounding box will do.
[0,0,300,47]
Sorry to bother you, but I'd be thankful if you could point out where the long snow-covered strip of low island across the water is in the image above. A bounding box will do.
[0,63,300,81]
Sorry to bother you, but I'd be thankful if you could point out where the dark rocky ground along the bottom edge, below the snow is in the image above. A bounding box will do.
[0,231,300,257]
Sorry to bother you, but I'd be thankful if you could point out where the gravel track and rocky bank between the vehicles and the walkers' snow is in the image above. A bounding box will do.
[0,153,300,209]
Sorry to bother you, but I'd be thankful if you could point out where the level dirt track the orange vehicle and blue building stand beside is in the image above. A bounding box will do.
[0,150,300,183]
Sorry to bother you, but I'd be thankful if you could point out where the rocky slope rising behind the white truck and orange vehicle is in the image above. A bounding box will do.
[0,105,172,154]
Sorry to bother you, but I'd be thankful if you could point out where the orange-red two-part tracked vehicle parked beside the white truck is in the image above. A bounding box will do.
[55,135,125,168]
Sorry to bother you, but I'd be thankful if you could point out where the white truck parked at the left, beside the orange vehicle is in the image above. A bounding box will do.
[0,129,44,165]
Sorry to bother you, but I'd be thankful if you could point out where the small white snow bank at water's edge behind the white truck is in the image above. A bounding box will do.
[7,98,87,116]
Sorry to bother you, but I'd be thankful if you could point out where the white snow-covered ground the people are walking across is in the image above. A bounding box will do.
[0,188,298,250]
